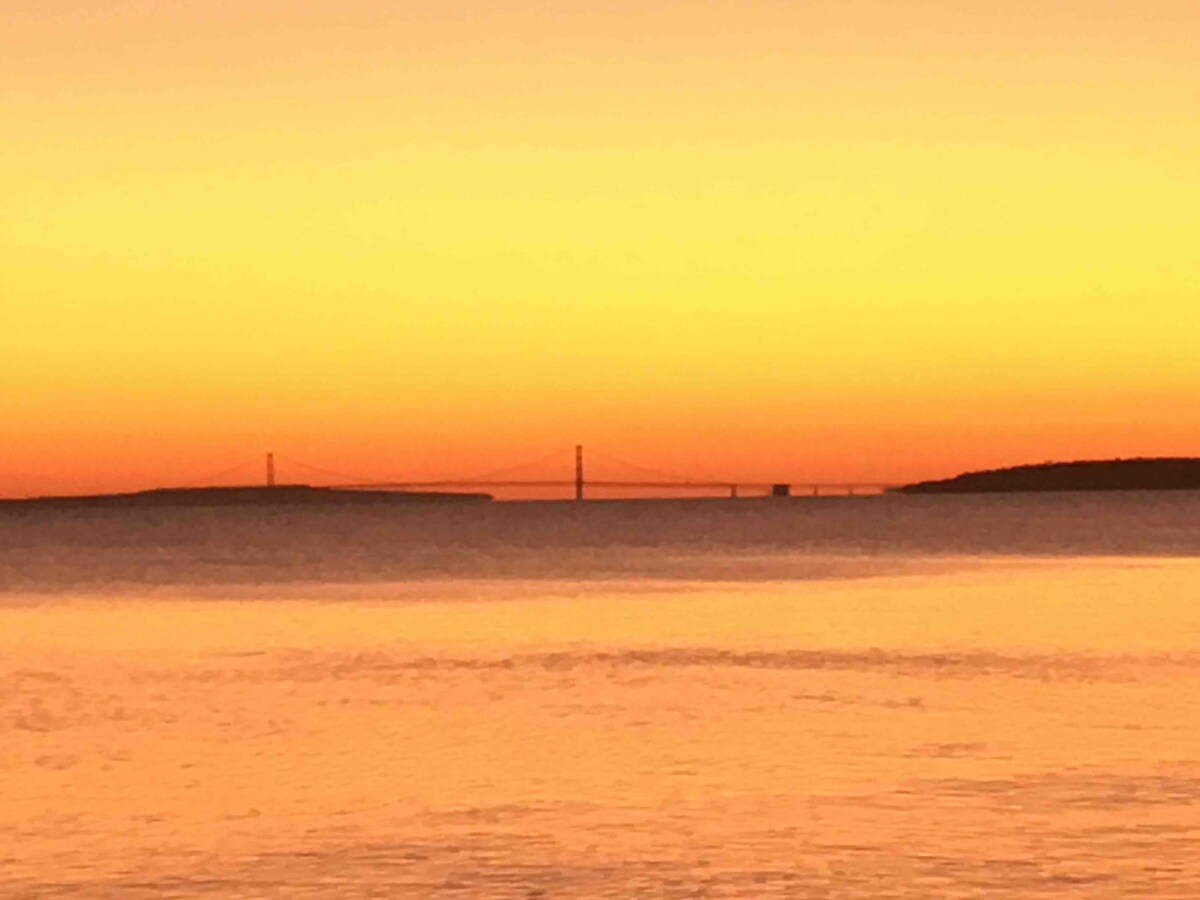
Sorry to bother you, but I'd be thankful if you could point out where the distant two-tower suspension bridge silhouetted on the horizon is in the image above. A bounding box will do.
[174,445,896,500]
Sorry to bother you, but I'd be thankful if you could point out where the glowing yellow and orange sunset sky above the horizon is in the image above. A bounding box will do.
[0,0,1200,496]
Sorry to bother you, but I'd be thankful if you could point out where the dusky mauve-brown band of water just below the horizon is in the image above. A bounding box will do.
[11,492,1200,598]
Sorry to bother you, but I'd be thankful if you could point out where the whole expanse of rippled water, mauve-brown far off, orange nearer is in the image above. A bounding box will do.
[0,493,1200,899]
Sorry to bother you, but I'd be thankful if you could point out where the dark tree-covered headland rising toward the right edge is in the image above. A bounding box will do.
[893,457,1200,493]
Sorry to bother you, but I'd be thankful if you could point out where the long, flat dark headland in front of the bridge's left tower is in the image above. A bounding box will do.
[0,485,492,508]
